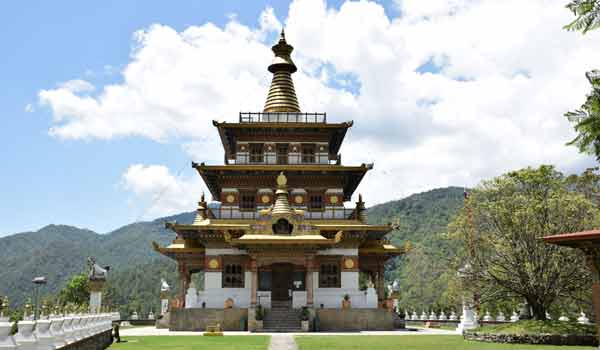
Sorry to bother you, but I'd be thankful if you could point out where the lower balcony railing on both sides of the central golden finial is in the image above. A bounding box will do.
[210,206,354,220]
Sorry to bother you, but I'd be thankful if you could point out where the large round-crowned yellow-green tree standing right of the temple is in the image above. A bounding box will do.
[450,165,598,320]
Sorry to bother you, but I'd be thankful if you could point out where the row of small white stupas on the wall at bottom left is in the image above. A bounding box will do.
[0,313,119,350]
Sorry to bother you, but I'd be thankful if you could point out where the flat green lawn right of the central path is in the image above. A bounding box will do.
[296,335,593,350]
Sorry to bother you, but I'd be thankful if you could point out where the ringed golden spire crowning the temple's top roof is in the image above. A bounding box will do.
[264,29,300,112]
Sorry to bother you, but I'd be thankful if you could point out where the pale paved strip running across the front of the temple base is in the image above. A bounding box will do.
[120,326,456,337]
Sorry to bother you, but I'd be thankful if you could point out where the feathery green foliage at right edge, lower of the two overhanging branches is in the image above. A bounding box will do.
[565,70,600,161]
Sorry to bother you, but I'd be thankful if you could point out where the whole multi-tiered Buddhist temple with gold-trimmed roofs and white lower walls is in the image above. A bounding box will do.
[154,31,403,330]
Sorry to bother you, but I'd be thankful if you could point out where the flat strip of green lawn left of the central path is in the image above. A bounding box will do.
[109,335,270,350]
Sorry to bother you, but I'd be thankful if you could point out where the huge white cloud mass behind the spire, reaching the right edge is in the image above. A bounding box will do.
[40,0,600,215]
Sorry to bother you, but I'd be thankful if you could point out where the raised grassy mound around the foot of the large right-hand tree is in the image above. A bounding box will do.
[475,321,596,335]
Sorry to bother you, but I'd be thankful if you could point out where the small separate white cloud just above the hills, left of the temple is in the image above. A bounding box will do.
[122,164,202,219]
